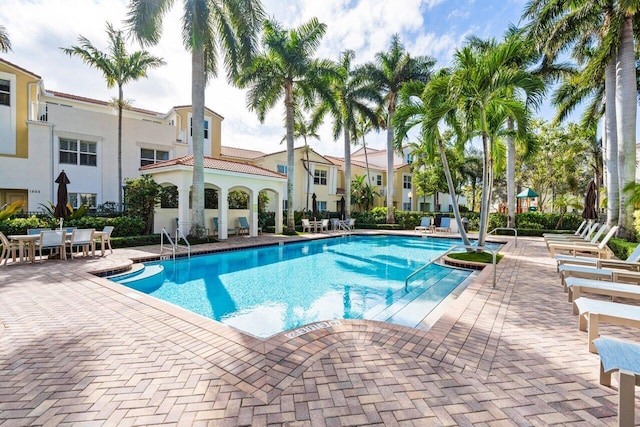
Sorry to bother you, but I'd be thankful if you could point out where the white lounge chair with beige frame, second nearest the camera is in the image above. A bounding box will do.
[573,297,640,353]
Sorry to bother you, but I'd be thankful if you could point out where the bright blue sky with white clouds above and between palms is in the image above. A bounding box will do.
[0,0,552,157]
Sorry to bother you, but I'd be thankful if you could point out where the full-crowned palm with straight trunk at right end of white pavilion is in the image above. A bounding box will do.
[238,18,336,233]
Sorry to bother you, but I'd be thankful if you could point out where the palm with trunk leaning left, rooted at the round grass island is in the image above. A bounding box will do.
[394,75,470,245]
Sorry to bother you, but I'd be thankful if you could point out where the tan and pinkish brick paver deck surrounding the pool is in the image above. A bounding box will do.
[0,232,640,426]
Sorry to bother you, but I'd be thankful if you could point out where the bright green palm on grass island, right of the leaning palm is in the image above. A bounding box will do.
[450,43,544,246]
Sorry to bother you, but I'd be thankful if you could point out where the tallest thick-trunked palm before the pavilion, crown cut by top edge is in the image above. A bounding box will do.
[127,0,264,237]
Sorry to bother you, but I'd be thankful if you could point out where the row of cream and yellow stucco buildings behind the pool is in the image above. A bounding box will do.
[0,59,462,238]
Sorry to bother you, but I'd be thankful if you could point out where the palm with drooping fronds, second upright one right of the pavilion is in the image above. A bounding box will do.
[313,50,382,218]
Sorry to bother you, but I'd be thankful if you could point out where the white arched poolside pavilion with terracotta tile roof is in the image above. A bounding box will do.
[145,156,287,239]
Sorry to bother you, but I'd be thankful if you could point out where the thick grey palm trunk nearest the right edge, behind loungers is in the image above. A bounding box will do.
[616,16,638,237]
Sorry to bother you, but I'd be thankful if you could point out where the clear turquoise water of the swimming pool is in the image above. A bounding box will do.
[115,236,478,337]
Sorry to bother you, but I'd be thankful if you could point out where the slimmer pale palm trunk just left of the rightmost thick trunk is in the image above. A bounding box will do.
[604,59,620,231]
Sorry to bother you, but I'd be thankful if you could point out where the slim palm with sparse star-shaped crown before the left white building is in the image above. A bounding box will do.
[61,23,165,209]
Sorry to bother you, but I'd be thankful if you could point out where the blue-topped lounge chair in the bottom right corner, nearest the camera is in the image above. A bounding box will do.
[593,337,640,426]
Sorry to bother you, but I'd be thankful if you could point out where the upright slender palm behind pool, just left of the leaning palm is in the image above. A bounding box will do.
[360,34,435,224]
